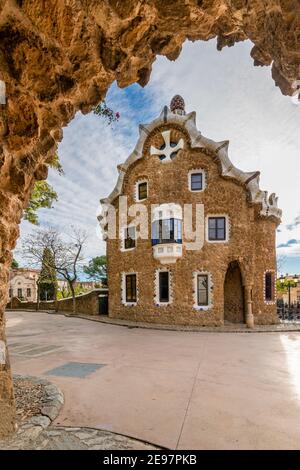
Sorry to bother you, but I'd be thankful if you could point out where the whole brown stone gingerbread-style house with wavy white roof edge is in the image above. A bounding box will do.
[99,95,281,327]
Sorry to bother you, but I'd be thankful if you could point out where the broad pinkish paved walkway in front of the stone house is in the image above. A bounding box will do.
[7,312,300,449]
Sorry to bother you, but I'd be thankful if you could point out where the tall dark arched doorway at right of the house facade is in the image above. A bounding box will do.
[224,261,245,323]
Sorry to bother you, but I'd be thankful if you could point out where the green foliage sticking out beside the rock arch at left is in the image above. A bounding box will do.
[24,154,64,225]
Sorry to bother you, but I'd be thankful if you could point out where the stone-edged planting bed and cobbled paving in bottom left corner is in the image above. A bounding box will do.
[0,375,159,450]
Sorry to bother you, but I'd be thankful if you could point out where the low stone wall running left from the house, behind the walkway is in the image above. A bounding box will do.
[7,289,108,315]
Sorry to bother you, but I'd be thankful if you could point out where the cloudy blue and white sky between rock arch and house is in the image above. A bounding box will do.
[15,40,300,274]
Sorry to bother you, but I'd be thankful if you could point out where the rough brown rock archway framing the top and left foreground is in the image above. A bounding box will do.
[0,0,300,435]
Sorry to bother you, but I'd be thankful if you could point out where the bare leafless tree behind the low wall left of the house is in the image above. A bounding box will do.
[22,227,87,313]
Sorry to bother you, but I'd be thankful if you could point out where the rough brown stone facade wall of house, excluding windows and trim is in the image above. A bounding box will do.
[107,124,278,326]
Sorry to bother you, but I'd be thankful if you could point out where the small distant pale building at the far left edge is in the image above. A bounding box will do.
[9,268,40,302]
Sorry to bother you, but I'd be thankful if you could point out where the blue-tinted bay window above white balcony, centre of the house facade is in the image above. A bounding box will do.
[152,219,182,245]
